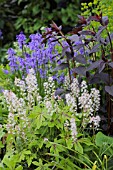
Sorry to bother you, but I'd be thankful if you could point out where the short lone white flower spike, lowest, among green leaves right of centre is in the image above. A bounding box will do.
[70,118,78,142]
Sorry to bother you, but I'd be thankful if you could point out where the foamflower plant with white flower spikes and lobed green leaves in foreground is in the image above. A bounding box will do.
[0,69,113,170]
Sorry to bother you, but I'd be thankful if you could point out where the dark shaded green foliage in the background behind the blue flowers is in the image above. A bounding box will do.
[0,0,91,64]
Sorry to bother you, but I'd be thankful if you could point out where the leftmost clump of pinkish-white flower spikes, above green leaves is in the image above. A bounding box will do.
[3,90,29,136]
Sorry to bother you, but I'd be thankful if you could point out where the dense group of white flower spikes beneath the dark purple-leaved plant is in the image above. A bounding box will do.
[65,78,100,127]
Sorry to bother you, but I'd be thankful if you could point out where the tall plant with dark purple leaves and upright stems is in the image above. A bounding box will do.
[42,13,113,133]
